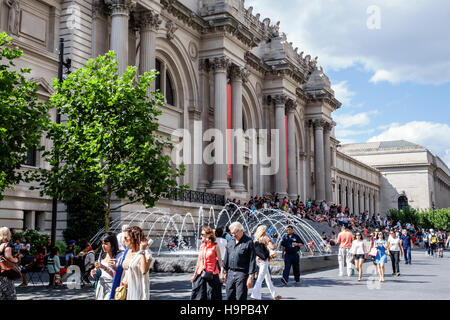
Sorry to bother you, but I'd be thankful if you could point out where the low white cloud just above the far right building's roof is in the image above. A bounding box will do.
[368,121,450,167]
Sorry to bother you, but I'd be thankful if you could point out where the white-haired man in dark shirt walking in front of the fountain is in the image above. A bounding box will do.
[220,221,256,300]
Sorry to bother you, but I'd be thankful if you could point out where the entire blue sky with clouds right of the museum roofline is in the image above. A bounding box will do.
[245,0,450,167]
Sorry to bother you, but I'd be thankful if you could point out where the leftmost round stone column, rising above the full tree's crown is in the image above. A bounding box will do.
[107,0,132,74]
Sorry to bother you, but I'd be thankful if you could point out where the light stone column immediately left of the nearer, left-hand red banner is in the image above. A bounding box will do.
[207,57,230,192]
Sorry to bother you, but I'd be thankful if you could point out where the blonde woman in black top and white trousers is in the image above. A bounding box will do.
[251,225,281,300]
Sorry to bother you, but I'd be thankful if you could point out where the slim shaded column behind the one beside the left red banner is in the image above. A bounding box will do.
[198,59,210,191]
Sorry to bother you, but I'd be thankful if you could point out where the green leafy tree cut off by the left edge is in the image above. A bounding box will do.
[0,32,50,200]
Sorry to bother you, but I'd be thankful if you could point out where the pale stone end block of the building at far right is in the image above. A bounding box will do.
[339,140,450,213]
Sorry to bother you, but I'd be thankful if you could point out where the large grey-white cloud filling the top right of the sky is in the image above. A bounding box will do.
[246,0,450,84]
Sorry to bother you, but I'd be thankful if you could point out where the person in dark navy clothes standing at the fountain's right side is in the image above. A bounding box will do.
[281,225,305,285]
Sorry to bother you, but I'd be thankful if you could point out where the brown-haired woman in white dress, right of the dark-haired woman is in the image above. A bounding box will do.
[116,226,153,300]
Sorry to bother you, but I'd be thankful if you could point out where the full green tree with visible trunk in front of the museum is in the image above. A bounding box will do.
[34,52,184,230]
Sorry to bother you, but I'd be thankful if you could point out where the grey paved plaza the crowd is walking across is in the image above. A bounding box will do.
[16,250,450,300]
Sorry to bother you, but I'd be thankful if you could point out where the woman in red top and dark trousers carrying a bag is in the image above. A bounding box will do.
[191,227,222,300]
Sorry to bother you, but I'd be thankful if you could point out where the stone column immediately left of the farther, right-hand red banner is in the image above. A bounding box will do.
[272,94,287,199]
